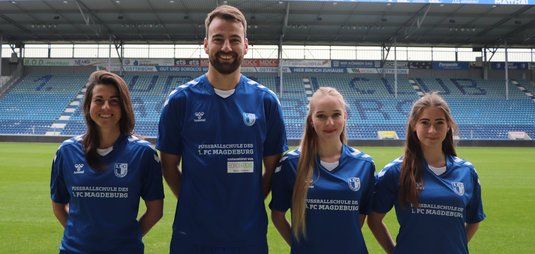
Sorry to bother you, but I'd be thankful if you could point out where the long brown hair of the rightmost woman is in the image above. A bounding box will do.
[399,92,457,207]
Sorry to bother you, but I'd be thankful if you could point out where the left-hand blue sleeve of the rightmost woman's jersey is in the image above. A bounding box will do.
[372,167,399,213]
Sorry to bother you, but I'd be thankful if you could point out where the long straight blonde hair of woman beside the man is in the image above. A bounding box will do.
[292,87,347,241]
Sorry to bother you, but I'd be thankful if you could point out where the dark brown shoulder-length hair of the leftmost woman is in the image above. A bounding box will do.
[82,71,135,170]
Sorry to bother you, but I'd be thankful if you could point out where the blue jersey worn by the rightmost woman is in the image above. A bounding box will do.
[373,156,485,253]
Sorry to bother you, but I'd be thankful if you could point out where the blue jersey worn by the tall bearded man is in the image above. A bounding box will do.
[156,75,287,250]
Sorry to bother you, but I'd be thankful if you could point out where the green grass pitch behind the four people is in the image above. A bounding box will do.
[0,143,535,254]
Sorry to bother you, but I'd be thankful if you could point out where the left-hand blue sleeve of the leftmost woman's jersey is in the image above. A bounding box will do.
[50,149,70,204]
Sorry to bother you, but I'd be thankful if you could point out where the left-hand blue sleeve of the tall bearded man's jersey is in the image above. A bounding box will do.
[156,90,186,155]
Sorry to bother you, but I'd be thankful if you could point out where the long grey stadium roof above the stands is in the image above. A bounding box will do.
[0,0,535,48]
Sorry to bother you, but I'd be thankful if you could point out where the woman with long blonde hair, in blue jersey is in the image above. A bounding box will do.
[269,87,375,254]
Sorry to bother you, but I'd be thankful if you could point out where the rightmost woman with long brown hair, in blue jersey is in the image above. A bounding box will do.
[368,93,485,253]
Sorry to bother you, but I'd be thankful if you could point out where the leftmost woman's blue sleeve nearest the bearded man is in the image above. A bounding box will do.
[141,148,164,201]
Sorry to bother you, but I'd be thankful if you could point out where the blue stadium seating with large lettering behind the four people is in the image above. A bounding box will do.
[0,73,535,140]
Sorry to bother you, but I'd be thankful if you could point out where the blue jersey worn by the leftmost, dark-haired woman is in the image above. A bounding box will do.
[50,135,164,253]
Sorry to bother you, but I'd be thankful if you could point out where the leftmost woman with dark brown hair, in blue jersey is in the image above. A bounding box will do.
[50,71,164,253]
